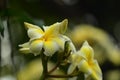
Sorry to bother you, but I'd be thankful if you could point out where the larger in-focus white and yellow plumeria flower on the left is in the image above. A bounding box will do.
[19,19,73,56]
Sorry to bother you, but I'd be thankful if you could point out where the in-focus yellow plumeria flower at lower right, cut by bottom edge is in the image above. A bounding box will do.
[68,41,102,80]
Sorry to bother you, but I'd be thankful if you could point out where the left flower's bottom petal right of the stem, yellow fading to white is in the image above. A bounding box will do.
[44,41,59,56]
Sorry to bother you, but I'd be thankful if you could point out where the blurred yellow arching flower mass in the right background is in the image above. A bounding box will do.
[68,24,120,66]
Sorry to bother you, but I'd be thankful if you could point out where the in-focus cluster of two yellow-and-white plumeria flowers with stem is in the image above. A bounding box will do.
[19,19,102,80]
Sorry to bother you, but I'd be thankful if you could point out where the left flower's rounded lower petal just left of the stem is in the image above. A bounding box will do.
[30,40,43,56]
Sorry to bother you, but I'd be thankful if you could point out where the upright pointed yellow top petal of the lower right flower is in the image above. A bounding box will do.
[80,41,94,60]
